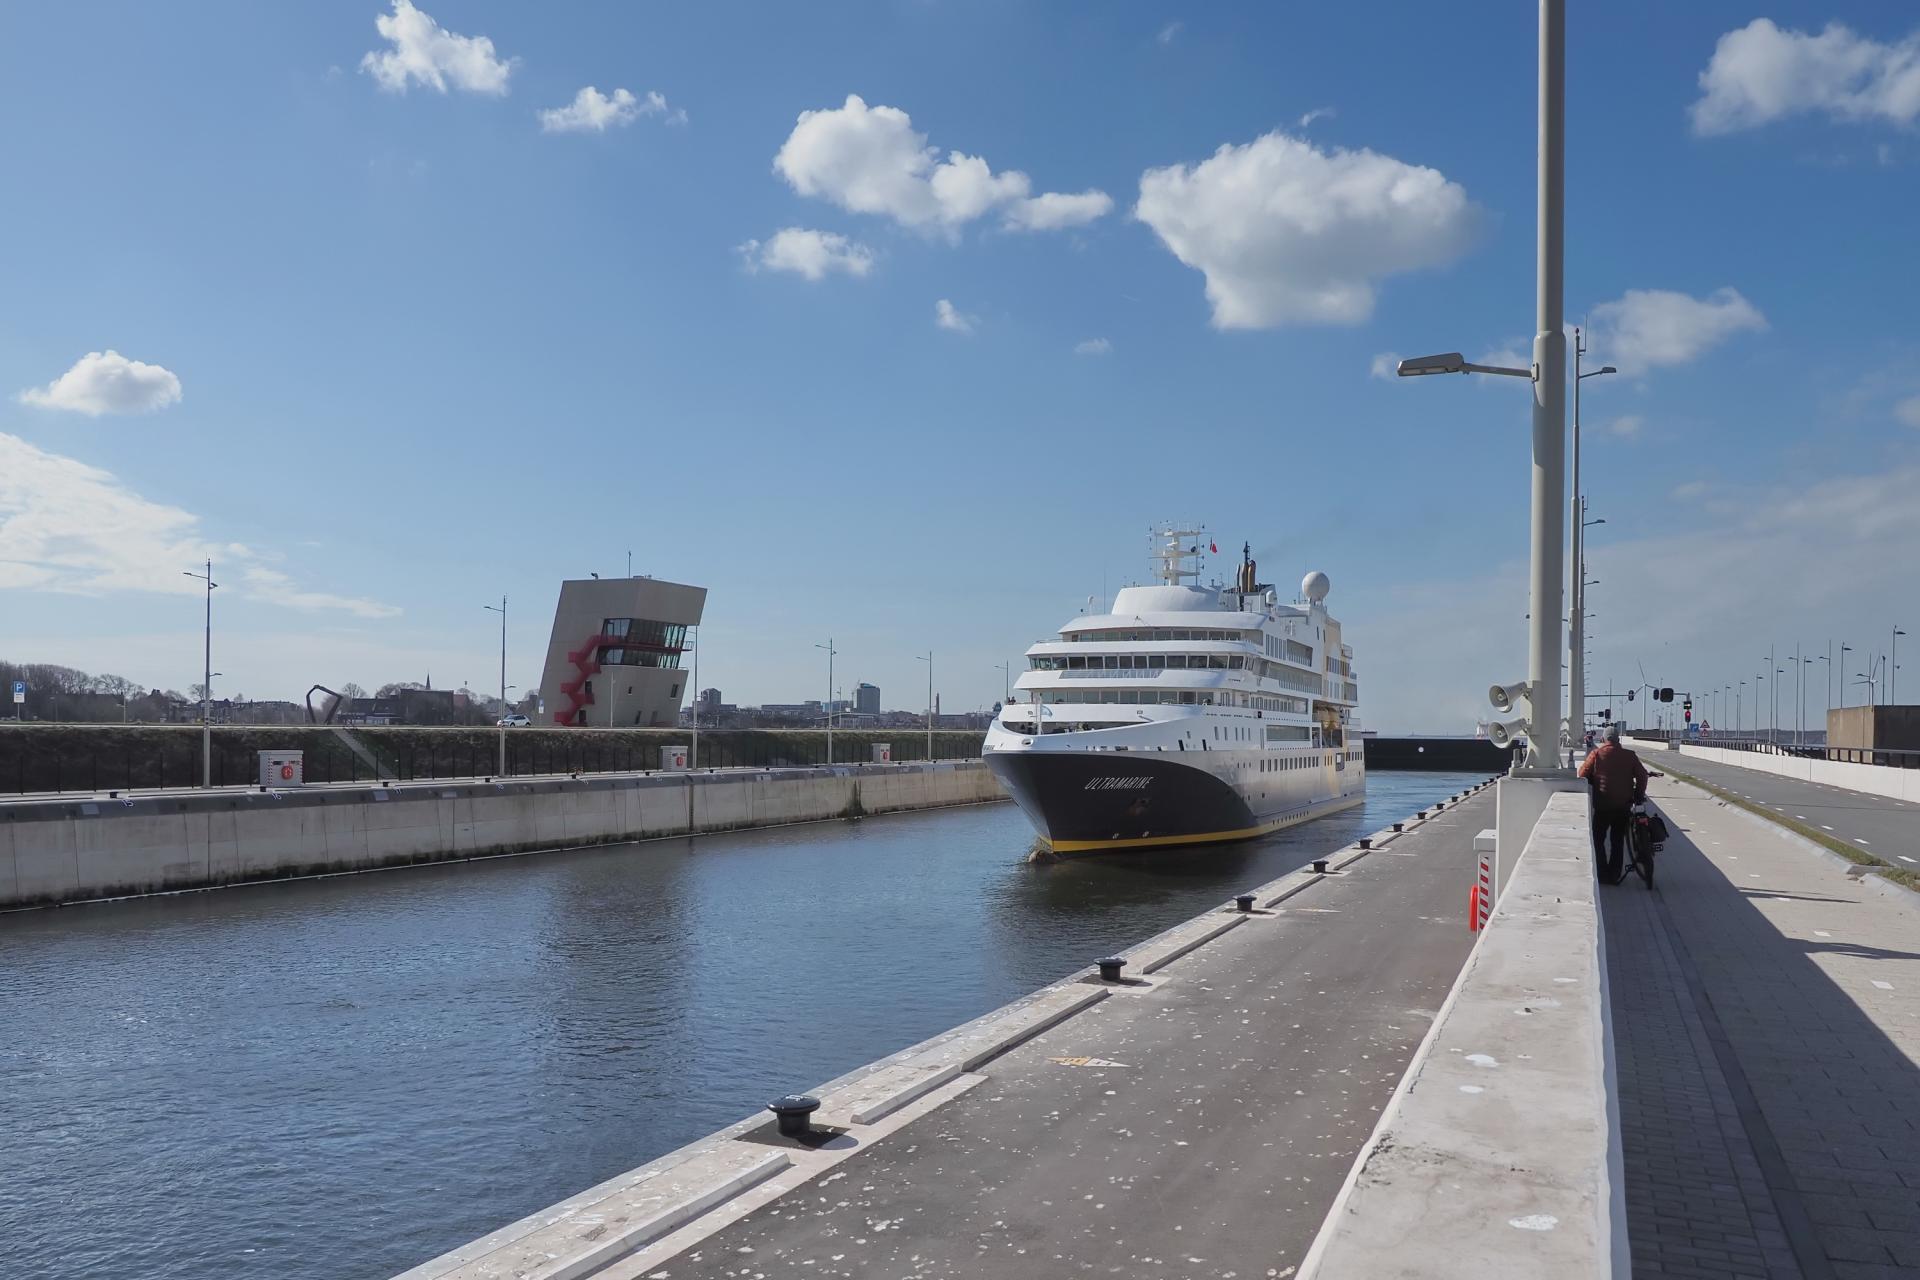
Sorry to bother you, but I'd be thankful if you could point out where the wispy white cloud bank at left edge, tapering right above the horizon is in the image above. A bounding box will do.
[0,434,399,618]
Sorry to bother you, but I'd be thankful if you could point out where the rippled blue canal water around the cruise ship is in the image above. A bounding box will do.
[0,771,1480,1280]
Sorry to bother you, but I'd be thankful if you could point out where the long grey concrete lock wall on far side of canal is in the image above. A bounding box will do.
[0,760,1004,908]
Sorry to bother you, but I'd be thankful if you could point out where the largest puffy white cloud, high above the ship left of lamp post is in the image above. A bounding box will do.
[1135,132,1480,328]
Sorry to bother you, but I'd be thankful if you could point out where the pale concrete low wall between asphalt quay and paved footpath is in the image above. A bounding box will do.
[1300,793,1628,1280]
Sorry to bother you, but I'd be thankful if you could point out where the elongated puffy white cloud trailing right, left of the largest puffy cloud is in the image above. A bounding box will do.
[774,94,1114,234]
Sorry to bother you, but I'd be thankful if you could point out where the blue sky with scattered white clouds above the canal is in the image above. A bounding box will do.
[0,0,1920,731]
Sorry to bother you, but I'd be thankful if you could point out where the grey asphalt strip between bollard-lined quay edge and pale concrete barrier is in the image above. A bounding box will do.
[649,794,1494,1280]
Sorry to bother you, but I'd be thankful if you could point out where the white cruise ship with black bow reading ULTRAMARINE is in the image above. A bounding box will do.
[983,528,1367,854]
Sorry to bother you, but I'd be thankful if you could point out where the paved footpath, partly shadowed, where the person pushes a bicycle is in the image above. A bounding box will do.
[1601,771,1920,1280]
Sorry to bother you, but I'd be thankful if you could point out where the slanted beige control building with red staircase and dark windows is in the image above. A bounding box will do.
[540,578,707,729]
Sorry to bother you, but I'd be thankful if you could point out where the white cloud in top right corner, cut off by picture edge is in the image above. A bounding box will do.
[1692,17,1920,134]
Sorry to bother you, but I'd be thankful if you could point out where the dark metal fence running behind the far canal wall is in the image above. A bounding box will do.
[0,731,983,794]
